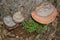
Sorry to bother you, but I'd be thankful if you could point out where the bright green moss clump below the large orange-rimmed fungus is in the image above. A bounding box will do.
[23,18,47,33]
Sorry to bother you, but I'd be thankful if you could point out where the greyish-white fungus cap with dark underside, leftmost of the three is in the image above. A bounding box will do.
[3,15,16,27]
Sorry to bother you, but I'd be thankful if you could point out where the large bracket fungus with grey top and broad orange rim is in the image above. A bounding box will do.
[31,2,58,24]
